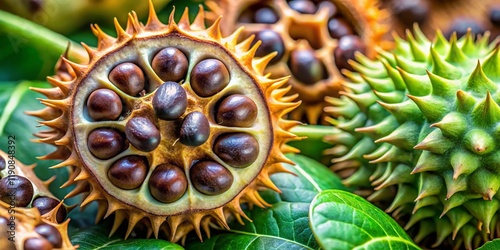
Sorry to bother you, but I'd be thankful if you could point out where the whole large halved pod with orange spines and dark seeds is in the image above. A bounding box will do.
[31,2,300,242]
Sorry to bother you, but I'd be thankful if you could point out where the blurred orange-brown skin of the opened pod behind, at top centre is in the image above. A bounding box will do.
[206,0,391,124]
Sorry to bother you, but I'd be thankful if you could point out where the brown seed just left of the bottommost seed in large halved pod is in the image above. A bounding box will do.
[108,155,149,190]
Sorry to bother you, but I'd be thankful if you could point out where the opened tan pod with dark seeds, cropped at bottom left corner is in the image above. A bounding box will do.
[0,151,75,250]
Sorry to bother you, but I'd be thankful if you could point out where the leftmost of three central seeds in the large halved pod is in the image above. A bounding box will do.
[125,116,161,152]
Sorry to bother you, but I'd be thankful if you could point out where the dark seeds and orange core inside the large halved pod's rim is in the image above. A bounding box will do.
[77,39,266,211]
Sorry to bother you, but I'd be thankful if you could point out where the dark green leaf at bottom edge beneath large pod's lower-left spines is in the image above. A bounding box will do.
[71,224,184,250]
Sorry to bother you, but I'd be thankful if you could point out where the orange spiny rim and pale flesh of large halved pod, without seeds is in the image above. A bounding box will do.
[31,3,300,242]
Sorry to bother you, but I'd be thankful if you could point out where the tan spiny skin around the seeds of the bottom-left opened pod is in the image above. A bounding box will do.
[0,151,76,250]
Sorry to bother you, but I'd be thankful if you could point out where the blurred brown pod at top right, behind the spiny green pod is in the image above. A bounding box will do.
[386,0,500,37]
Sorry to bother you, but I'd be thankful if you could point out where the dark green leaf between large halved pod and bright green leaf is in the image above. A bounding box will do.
[186,155,345,249]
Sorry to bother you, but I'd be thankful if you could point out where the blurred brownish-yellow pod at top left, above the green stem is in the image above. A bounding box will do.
[0,0,170,33]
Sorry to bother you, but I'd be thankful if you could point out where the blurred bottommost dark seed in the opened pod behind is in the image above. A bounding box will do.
[288,49,326,85]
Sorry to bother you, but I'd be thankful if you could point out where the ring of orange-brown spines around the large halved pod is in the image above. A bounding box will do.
[30,2,300,242]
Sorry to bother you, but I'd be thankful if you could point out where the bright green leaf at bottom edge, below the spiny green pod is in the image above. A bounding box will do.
[309,190,420,249]
